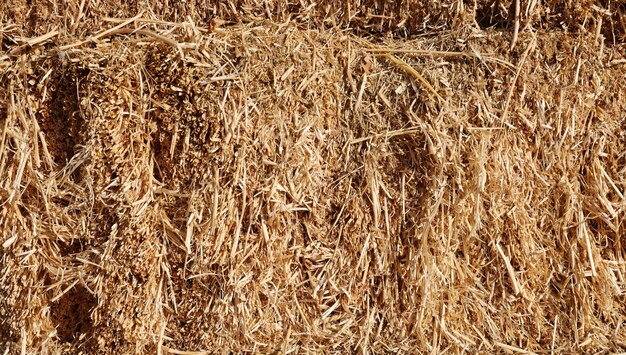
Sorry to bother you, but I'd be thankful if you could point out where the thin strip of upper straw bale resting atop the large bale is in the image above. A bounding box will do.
[0,0,626,39]
